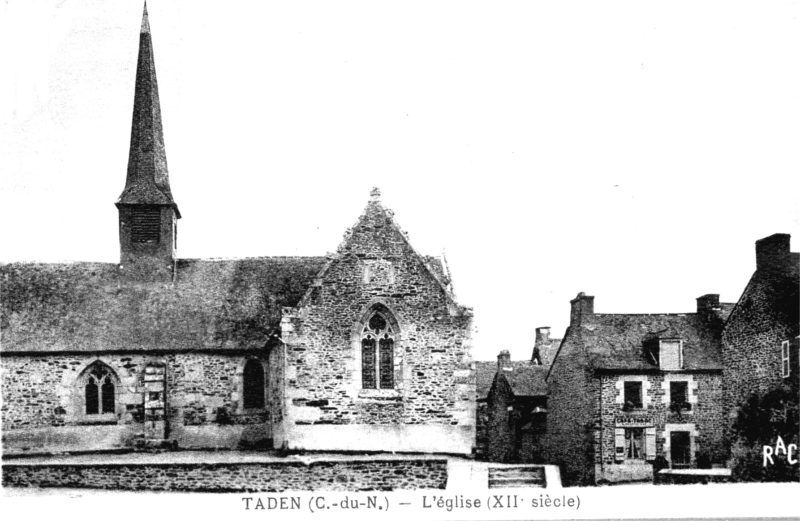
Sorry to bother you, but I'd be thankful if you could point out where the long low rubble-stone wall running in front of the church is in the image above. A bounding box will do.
[2,459,447,492]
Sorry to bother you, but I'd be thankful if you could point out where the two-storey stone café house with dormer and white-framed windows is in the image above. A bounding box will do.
[545,293,731,485]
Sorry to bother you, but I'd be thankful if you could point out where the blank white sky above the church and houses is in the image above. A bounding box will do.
[0,0,800,359]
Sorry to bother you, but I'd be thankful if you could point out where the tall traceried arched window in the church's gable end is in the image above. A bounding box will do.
[361,311,395,389]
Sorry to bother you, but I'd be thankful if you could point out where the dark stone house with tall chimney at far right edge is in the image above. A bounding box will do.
[722,234,800,481]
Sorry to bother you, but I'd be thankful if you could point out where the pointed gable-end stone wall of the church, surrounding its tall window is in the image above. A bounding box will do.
[282,197,475,453]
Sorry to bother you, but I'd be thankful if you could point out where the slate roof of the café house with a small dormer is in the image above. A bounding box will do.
[577,310,731,370]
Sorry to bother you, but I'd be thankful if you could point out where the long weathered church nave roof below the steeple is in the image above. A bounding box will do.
[0,257,325,353]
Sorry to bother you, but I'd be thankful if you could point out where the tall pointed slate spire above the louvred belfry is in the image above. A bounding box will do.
[117,2,181,219]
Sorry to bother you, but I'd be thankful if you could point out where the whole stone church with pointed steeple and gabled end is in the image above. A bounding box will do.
[0,10,475,454]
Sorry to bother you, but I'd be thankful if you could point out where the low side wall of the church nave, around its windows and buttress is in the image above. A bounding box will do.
[0,353,276,452]
